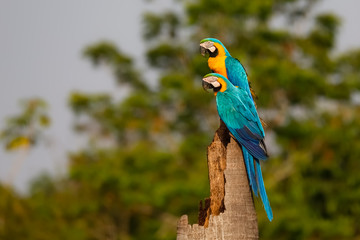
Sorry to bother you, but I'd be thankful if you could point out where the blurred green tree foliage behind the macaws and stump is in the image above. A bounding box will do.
[0,0,360,240]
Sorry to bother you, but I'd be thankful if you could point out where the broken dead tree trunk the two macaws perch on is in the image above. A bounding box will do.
[177,121,259,240]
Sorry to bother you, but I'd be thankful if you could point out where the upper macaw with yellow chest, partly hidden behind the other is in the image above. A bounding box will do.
[200,38,256,99]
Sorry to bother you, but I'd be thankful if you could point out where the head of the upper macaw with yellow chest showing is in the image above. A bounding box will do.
[200,38,231,57]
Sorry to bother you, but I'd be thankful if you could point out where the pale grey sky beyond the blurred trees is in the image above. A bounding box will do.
[0,0,360,192]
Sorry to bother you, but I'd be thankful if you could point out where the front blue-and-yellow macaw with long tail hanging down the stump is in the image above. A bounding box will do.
[203,73,273,221]
